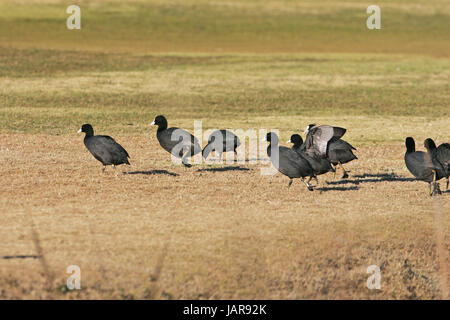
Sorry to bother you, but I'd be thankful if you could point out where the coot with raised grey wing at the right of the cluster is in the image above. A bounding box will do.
[305,124,358,178]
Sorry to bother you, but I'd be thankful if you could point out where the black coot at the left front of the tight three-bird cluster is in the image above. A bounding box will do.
[266,132,314,191]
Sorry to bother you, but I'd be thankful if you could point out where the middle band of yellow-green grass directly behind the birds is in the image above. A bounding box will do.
[0,48,450,139]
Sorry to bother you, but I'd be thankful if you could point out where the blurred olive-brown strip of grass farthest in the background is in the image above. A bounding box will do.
[0,0,450,57]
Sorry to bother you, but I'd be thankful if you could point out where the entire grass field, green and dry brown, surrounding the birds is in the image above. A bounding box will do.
[0,0,450,299]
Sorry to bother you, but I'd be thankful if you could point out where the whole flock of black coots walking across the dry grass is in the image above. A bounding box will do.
[78,115,450,195]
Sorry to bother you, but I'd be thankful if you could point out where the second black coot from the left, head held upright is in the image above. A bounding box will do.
[151,115,202,167]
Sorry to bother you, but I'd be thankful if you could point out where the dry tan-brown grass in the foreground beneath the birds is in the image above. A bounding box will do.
[0,130,450,299]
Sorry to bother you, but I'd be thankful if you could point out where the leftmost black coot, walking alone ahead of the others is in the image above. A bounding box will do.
[78,124,130,171]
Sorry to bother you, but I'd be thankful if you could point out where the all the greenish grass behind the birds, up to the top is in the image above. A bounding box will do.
[0,0,450,139]
